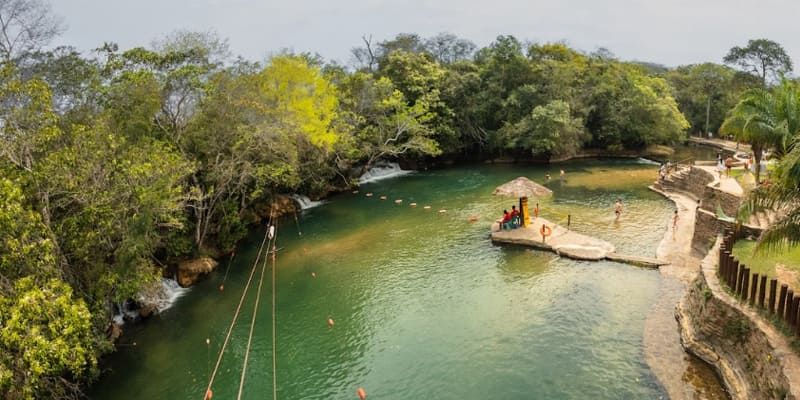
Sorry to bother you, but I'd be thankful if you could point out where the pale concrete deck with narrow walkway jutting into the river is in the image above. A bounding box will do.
[492,217,667,268]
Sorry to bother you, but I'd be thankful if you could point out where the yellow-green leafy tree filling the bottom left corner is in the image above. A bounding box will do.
[0,277,97,400]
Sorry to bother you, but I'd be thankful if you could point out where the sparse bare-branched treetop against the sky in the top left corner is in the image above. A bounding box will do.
[0,0,64,61]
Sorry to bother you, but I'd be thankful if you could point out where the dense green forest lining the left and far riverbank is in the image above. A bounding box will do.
[0,0,791,399]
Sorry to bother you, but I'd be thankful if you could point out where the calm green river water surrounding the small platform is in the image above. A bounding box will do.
[89,161,700,400]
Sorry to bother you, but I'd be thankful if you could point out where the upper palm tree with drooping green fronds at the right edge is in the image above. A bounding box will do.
[720,79,800,184]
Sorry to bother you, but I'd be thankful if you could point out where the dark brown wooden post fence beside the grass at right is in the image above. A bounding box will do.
[719,230,800,336]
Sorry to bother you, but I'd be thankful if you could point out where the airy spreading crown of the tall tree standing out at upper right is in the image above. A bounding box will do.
[723,39,792,86]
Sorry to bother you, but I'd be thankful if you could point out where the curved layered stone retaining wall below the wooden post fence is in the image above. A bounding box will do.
[676,247,796,399]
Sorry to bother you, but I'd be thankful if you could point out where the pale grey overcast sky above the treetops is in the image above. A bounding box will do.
[52,0,800,70]
